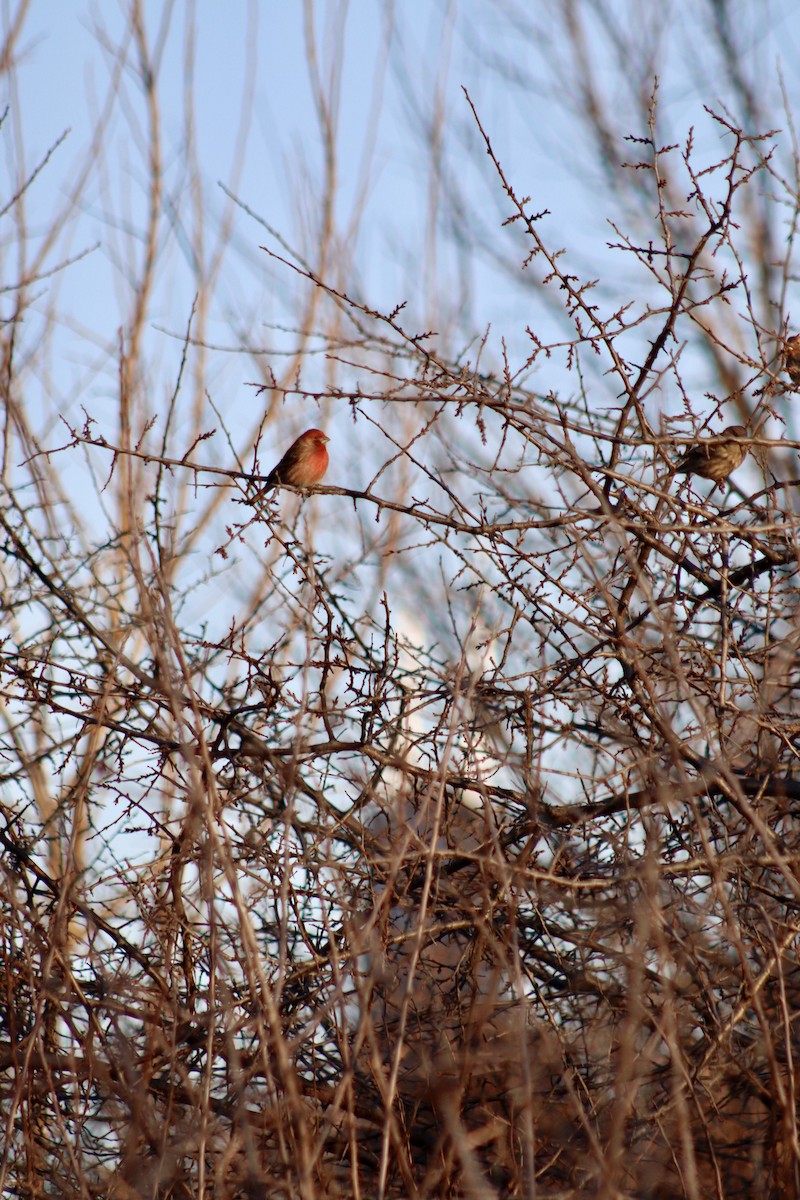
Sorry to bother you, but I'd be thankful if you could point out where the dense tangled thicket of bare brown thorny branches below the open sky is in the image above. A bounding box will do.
[0,2,800,1200]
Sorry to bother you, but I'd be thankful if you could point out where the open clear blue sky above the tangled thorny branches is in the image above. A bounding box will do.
[2,0,800,492]
